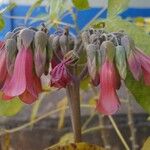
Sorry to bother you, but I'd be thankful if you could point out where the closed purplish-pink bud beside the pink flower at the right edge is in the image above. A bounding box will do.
[128,52,142,81]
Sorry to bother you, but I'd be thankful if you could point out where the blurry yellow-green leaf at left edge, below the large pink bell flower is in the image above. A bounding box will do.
[0,98,23,116]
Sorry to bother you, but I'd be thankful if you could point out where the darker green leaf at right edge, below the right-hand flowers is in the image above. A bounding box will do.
[125,71,150,113]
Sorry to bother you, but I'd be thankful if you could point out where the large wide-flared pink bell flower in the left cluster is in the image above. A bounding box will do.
[3,48,42,103]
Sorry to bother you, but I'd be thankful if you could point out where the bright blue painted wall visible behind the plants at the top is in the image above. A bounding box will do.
[0,6,150,39]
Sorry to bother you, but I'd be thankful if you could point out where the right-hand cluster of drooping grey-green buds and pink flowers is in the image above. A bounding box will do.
[82,29,150,115]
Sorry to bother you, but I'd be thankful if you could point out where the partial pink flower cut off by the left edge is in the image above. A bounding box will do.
[0,42,7,89]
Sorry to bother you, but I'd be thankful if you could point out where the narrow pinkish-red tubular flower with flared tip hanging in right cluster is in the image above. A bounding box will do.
[97,60,120,115]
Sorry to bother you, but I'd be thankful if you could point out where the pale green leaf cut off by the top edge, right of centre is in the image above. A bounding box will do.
[107,0,130,17]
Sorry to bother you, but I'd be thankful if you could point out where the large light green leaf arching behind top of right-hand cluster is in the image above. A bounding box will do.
[106,17,150,54]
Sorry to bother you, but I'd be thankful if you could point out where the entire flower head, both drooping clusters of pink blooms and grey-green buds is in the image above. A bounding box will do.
[0,27,150,115]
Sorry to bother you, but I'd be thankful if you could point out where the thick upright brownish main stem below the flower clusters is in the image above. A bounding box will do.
[66,82,81,142]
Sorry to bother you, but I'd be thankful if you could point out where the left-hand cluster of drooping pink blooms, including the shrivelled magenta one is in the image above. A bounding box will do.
[0,27,77,104]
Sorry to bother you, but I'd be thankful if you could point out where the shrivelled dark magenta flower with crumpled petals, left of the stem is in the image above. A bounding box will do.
[50,61,72,88]
